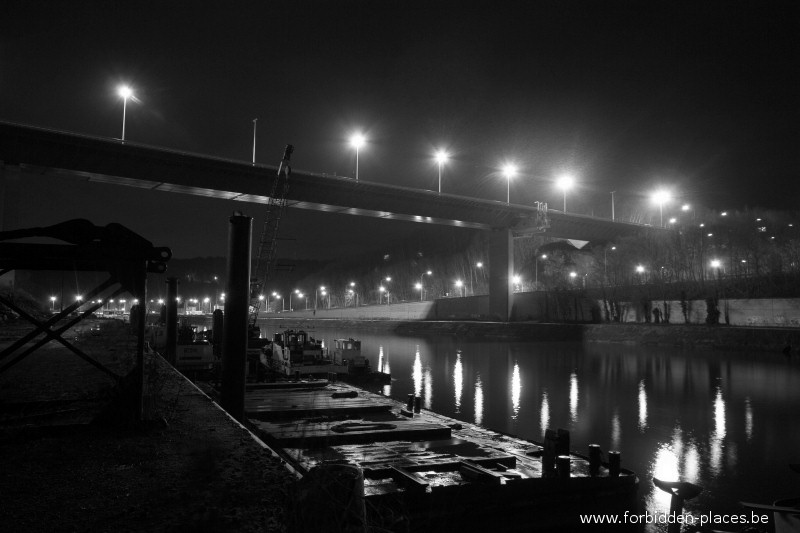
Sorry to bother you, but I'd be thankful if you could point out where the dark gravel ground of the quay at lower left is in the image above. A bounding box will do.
[0,321,294,532]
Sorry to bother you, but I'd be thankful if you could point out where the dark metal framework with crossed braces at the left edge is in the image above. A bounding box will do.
[0,219,172,419]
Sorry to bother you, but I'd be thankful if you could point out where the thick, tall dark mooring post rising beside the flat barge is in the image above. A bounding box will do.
[220,214,253,422]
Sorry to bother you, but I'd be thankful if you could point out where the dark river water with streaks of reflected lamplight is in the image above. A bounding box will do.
[253,327,800,531]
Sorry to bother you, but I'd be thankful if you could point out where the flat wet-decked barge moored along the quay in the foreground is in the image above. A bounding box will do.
[245,380,638,533]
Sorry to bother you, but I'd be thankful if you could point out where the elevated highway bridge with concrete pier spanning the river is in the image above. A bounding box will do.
[0,122,656,320]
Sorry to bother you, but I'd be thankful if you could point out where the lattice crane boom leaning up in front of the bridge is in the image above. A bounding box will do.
[250,144,294,331]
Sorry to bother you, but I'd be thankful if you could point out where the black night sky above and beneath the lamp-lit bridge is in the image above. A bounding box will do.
[0,0,800,257]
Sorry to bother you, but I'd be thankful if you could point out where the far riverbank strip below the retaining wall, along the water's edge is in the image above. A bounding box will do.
[250,317,800,355]
